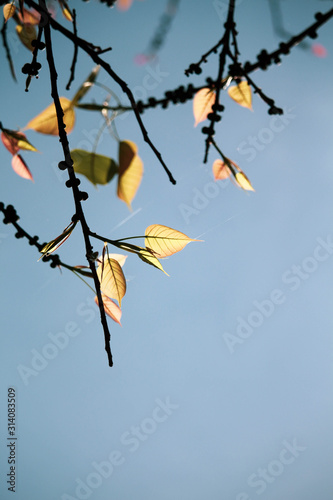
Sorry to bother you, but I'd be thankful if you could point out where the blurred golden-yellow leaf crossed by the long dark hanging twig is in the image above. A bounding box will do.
[25,97,75,135]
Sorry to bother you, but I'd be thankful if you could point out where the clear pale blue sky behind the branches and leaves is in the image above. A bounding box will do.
[0,0,333,500]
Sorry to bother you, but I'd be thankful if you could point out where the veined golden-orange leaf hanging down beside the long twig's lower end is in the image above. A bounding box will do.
[97,255,126,307]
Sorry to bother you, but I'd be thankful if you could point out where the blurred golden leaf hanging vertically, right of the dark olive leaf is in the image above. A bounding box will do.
[117,141,143,210]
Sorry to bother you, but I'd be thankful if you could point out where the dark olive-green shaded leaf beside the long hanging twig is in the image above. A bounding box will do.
[71,149,118,186]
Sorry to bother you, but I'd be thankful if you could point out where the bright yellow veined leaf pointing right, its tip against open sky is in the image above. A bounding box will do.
[145,224,200,259]
